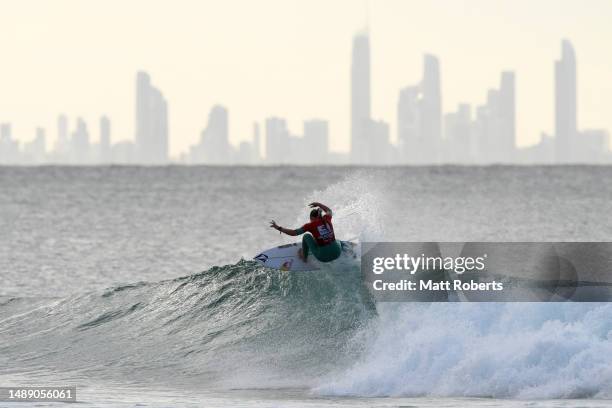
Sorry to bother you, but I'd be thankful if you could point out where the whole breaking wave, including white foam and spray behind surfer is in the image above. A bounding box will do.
[0,174,612,399]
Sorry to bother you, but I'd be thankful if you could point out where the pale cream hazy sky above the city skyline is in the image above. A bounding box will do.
[0,0,612,156]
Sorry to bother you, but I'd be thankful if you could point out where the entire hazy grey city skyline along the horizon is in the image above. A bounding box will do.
[0,30,612,165]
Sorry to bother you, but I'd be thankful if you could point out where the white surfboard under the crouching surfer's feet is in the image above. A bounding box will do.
[253,241,357,272]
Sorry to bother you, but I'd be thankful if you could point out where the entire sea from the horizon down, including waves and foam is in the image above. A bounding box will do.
[0,166,612,407]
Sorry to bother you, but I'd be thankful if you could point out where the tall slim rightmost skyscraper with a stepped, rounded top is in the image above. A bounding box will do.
[555,40,577,163]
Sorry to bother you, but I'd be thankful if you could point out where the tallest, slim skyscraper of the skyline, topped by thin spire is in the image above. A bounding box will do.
[351,33,371,163]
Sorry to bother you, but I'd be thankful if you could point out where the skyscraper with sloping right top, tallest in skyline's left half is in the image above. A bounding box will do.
[136,72,168,164]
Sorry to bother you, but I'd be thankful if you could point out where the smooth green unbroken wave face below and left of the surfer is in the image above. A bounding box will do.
[0,261,375,386]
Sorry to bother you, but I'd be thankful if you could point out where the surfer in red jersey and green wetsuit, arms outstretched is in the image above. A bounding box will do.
[270,202,342,262]
